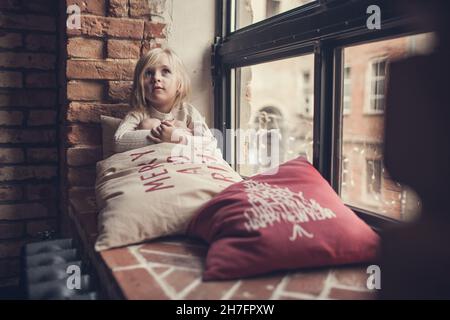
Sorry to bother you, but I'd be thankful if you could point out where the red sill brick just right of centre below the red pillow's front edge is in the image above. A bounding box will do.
[284,270,328,296]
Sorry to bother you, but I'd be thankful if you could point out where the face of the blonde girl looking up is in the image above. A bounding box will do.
[144,55,178,113]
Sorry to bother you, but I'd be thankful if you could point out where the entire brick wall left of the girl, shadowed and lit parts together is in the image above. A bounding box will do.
[0,0,170,287]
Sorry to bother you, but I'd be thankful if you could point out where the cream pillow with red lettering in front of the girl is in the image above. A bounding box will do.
[95,143,242,251]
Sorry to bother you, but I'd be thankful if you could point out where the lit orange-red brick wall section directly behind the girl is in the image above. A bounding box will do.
[61,0,168,224]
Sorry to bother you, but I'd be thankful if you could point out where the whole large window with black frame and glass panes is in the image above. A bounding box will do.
[218,0,432,226]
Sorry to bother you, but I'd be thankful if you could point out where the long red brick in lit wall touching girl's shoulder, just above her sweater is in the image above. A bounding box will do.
[67,102,130,123]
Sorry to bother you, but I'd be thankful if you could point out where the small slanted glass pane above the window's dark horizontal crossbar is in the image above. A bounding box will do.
[234,0,315,30]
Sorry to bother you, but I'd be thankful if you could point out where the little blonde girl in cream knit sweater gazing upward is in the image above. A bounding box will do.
[114,48,215,152]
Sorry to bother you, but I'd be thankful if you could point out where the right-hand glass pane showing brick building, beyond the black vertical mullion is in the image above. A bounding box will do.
[341,34,434,220]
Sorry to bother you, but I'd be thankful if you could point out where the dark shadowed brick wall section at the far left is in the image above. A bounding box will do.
[0,0,59,287]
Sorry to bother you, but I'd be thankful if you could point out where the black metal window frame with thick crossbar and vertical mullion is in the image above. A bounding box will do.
[213,0,430,230]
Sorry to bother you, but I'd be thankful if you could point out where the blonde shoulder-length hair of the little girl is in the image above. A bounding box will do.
[130,48,191,112]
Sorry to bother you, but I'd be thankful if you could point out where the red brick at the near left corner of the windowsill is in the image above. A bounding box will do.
[114,268,169,300]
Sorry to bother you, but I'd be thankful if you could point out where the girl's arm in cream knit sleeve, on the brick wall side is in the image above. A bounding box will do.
[114,112,153,152]
